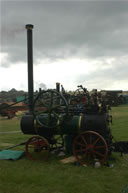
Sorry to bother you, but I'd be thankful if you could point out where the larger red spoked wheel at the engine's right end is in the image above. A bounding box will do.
[73,131,108,165]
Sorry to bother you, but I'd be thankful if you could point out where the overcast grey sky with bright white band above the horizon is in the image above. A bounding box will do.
[0,0,128,91]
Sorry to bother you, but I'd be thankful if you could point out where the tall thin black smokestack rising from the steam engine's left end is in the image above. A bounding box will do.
[25,24,34,113]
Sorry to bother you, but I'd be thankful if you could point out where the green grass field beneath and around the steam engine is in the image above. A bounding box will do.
[0,106,128,193]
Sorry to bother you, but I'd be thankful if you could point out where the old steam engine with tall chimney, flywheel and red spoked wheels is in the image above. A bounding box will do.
[21,25,112,165]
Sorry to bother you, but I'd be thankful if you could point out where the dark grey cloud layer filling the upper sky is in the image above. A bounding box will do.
[1,1,128,64]
